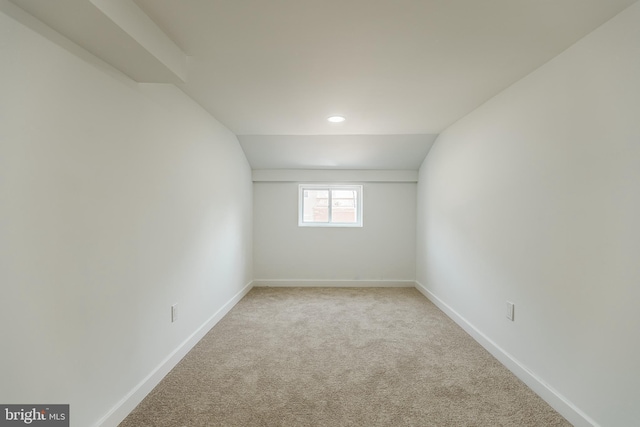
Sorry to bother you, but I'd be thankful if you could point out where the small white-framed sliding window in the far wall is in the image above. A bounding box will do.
[298,184,362,227]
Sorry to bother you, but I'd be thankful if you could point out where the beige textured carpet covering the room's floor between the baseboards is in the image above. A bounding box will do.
[120,288,570,427]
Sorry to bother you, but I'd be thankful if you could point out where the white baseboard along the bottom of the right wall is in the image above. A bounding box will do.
[416,281,600,427]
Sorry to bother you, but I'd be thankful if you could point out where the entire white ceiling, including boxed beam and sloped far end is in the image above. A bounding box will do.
[11,0,636,169]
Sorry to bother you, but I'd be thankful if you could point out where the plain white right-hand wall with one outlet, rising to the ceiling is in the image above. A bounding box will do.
[417,3,640,427]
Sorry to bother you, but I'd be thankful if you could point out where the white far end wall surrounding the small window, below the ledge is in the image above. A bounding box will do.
[253,182,416,285]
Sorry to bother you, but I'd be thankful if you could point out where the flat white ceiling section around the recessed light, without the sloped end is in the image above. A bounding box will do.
[136,0,633,135]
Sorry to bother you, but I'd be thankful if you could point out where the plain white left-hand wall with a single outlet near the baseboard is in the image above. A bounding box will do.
[0,6,252,426]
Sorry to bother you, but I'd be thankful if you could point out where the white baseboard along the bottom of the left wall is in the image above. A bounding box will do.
[96,282,253,427]
